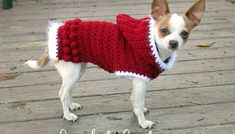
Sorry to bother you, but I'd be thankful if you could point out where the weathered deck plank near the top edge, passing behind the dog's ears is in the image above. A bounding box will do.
[0,2,235,21]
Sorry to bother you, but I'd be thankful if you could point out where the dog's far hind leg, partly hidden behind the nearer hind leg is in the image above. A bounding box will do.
[69,63,87,110]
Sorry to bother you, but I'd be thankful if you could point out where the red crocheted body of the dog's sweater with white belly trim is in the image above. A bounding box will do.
[54,14,175,80]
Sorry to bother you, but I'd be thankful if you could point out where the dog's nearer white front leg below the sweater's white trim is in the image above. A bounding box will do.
[131,79,155,128]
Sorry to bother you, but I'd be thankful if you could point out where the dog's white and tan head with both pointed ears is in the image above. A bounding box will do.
[151,0,205,52]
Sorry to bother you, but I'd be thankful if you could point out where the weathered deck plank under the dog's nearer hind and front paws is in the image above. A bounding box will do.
[0,103,235,134]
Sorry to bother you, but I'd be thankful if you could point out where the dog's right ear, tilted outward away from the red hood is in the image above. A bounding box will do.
[185,0,206,27]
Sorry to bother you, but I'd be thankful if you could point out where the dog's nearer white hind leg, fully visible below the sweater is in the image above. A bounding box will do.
[55,61,81,121]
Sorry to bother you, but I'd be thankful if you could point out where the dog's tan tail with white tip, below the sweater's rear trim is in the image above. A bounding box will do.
[25,47,49,69]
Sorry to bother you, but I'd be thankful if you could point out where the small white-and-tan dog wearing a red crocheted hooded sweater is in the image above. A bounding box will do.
[26,0,205,128]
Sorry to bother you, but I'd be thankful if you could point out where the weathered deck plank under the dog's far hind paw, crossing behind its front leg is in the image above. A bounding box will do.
[0,85,235,124]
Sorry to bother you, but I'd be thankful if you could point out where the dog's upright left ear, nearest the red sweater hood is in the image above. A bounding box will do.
[151,0,170,20]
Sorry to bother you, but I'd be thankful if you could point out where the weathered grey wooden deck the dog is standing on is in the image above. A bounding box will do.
[0,0,235,134]
